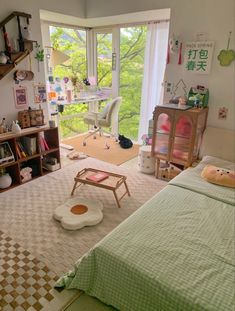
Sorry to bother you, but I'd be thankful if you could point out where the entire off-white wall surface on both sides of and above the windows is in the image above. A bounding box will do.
[0,0,235,129]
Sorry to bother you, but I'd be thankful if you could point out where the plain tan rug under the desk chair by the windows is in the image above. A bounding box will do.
[62,134,139,165]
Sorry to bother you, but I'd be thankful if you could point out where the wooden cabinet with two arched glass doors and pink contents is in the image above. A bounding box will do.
[152,106,208,177]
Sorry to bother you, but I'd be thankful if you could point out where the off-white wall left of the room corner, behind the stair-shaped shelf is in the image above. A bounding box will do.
[0,0,85,127]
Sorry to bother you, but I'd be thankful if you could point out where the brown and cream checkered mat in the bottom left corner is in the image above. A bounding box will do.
[0,231,58,311]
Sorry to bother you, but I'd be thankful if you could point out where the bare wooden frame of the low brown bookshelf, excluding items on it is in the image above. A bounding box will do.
[0,127,61,193]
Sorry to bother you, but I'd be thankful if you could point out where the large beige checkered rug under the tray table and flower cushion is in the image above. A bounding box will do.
[0,158,166,276]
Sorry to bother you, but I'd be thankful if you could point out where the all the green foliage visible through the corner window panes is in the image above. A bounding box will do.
[50,26,147,139]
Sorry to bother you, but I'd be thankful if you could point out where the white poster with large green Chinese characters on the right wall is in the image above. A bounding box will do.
[184,41,214,74]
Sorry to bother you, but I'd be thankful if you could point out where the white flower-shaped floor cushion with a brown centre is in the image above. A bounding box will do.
[53,198,103,230]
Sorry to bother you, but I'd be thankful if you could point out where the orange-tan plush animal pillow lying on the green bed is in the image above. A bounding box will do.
[201,165,235,188]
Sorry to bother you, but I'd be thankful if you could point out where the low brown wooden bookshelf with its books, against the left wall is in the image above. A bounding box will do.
[0,127,61,193]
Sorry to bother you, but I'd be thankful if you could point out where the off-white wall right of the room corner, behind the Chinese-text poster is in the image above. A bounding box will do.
[86,0,235,129]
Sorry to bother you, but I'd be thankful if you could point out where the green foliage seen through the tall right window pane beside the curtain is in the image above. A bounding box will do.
[119,26,147,139]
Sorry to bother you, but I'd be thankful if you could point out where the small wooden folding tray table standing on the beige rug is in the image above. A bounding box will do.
[71,168,130,208]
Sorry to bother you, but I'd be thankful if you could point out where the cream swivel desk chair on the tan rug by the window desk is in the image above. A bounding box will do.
[83,97,122,146]
